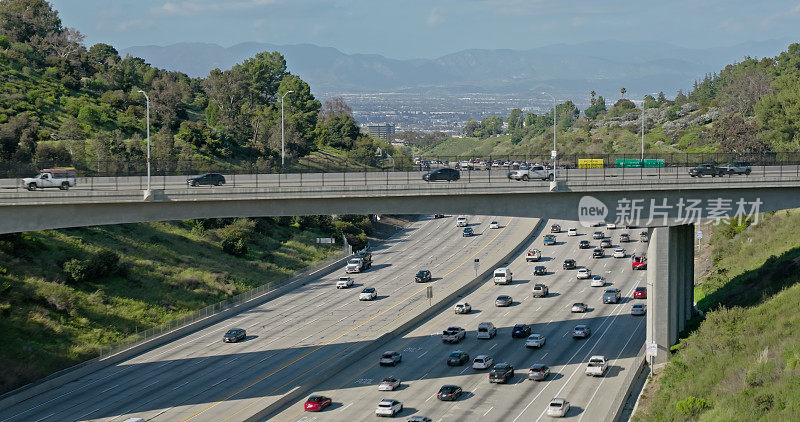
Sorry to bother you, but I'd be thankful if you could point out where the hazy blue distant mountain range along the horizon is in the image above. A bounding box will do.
[121,40,790,98]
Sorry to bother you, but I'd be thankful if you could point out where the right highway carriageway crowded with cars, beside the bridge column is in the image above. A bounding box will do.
[270,220,647,422]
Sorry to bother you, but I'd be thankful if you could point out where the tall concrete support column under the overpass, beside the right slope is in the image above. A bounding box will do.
[647,224,694,363]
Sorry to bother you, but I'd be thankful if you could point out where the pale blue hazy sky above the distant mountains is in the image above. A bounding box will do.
[51,0,800,59]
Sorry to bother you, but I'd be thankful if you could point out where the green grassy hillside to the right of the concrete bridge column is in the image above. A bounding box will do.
[634,210,800,421]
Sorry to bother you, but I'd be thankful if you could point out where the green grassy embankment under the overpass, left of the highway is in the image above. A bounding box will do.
[0,222,338,392]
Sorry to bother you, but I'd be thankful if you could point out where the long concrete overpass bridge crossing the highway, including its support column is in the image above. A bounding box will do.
[0,169,800,361]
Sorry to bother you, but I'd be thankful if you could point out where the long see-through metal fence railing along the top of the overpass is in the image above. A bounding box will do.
[0,152,800,190]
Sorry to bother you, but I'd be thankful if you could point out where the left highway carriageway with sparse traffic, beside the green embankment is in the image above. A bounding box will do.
[0,216,537,422]
